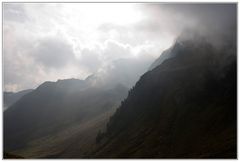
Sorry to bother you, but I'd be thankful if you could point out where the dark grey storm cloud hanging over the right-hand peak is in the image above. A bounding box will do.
[141,3,237,44]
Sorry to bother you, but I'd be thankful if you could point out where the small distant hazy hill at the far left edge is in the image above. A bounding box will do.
[3,89,32,110]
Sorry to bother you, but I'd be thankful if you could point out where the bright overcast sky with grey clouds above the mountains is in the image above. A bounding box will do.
[3,3,236,91]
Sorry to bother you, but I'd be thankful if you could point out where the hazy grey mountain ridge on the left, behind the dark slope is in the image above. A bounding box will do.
[4,79,127,158]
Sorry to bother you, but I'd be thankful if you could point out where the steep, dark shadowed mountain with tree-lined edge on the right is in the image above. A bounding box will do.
[91,39,237,158]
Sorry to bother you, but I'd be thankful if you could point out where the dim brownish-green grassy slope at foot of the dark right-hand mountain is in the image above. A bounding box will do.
[12,110,113,158]
